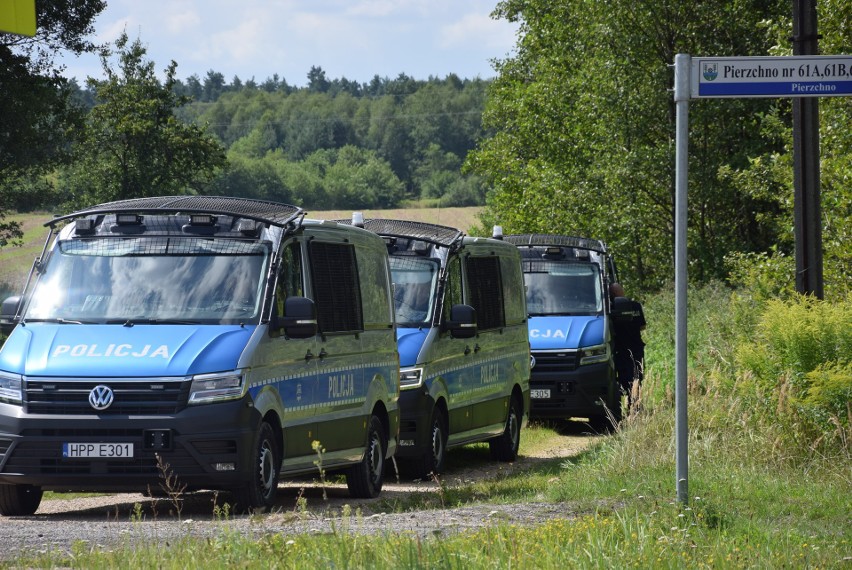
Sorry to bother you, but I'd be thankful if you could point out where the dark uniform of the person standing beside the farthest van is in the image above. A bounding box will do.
[612,297,646,406]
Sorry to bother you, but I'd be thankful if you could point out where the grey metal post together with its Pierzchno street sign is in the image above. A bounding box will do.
[674,54,852,504]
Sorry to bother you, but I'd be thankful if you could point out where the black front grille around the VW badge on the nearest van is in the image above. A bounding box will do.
[25,379,191,415]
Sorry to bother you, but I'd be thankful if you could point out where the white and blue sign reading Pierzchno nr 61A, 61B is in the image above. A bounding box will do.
[690,55,852,99]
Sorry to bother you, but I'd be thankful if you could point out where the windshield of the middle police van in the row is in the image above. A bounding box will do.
[390,256,441,326]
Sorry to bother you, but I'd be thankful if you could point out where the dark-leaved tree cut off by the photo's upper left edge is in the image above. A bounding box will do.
[0,0,106,240]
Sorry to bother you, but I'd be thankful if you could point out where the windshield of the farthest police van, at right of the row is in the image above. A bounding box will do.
[523,260,603,316]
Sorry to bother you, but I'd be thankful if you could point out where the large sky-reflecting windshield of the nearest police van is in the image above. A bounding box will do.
[24,238,269,324]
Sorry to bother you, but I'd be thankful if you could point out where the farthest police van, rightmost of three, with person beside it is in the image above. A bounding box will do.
[503,234,622,427]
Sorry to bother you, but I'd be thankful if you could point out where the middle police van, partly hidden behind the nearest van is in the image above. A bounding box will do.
[342,213,530,477]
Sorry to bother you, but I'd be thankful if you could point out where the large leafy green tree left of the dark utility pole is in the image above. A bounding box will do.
[466,0,790,288]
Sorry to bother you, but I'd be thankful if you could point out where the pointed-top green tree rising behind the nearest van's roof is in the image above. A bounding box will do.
[63,34,225,202]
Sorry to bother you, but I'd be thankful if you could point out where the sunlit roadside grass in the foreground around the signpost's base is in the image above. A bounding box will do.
[16,398,852,568]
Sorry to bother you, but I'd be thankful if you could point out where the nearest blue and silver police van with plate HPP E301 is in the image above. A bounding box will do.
[0,196,399,515]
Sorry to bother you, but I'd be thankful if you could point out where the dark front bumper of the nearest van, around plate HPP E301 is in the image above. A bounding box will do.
[0,397,261,492]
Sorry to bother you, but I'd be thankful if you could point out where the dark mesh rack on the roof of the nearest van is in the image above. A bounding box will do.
[44,196,305,227]
